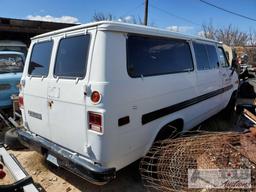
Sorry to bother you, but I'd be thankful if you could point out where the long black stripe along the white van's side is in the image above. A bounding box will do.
[141,85,233,125]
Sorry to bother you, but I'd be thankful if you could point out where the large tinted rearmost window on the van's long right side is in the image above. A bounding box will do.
[127,35,193,77]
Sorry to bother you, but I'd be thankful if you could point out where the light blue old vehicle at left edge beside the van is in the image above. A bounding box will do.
[0,51,25,109]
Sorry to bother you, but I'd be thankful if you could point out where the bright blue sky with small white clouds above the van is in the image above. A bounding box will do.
[0,0,256,35]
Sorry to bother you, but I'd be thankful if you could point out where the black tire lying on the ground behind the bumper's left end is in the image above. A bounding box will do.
[4,128,26,149]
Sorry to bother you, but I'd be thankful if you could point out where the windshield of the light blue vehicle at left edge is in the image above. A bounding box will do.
[0,54,24,73]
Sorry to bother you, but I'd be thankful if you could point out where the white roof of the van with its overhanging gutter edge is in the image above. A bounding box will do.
[31,21,220,43]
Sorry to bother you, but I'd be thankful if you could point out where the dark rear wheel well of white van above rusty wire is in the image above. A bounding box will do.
[155,119,184,141]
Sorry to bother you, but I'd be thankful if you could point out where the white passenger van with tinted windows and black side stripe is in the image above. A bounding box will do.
[19,21,238,184]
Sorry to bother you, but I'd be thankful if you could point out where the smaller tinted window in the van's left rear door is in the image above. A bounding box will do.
[28,41,53,76]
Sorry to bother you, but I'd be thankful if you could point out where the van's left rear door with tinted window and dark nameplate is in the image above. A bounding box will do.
[22,40,53,139]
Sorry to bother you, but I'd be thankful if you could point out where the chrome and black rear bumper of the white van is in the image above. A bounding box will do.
[17,129,116,185]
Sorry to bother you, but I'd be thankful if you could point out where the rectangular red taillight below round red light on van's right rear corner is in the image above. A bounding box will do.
[88,112,102,132]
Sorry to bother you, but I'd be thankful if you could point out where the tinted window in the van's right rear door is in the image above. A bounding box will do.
[54,35,90,78]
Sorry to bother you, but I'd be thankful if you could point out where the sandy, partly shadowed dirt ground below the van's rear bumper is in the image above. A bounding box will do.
[9,150,144,192]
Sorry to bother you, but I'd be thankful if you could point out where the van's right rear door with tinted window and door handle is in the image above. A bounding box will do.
[47,30,93,154]
